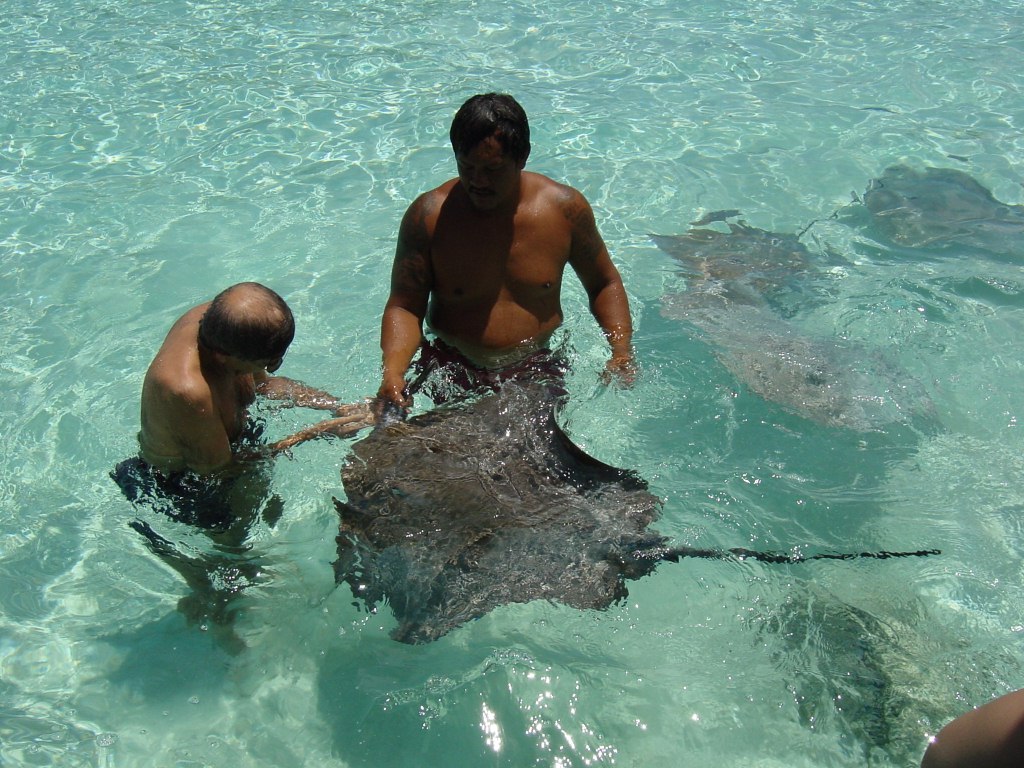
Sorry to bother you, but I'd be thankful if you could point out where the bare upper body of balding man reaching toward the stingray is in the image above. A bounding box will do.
[138,283,372,475]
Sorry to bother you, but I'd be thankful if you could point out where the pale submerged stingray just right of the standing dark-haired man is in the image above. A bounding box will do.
[651,219,929,431]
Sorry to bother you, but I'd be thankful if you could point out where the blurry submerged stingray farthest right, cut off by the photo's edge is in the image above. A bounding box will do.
[863,165,1024,258]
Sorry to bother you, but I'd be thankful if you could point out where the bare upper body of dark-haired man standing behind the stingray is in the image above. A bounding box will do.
[378,93,634,408]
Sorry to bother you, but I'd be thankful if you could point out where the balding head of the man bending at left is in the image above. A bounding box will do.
[199,283,295,361]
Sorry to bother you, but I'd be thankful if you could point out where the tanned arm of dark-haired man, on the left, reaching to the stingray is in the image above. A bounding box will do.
[377,193,433,408]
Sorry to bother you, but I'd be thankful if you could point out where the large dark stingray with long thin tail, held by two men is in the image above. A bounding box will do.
[335,382,934,643]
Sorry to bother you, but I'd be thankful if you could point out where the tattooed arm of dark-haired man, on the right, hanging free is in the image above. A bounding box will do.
[564,189,636,386]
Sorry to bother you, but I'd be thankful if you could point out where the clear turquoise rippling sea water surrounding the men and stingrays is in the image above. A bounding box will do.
[0,0,1024,768]
